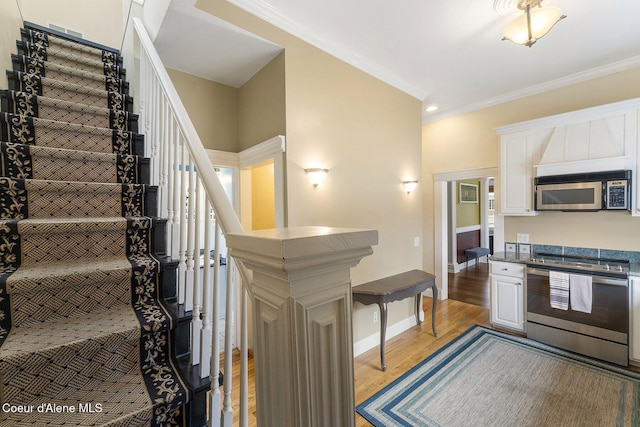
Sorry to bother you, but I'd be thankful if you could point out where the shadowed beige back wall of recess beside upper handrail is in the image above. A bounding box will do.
[167,69,240,153]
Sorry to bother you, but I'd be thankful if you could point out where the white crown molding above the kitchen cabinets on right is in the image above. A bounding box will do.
[422,55,640,124]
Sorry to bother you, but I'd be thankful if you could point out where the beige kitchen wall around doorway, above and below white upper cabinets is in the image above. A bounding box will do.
[422,69,640,270]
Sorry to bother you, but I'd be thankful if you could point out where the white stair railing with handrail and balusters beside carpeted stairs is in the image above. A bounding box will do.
[133,18,252,426]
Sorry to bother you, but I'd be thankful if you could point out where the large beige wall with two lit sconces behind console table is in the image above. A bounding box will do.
[196,0,424,341]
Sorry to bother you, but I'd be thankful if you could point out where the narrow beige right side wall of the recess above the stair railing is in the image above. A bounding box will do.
[238,53,286,151]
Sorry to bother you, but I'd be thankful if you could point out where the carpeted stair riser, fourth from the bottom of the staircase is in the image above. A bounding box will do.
[0,178,148,219]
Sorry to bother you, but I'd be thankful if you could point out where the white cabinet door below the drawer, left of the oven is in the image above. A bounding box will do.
[491,276,525,332]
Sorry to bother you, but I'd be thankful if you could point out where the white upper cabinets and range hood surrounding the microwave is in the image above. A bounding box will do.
[496,98,640,215]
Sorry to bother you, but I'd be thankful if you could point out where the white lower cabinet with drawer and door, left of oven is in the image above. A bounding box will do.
[489,261,526,332]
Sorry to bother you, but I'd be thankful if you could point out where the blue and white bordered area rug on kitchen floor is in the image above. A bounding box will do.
[356,326,640,427]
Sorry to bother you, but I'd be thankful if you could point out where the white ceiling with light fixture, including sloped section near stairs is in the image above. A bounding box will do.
[155,0,640,122]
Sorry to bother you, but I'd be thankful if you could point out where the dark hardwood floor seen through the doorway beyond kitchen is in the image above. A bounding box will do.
[448,262,489,308]
